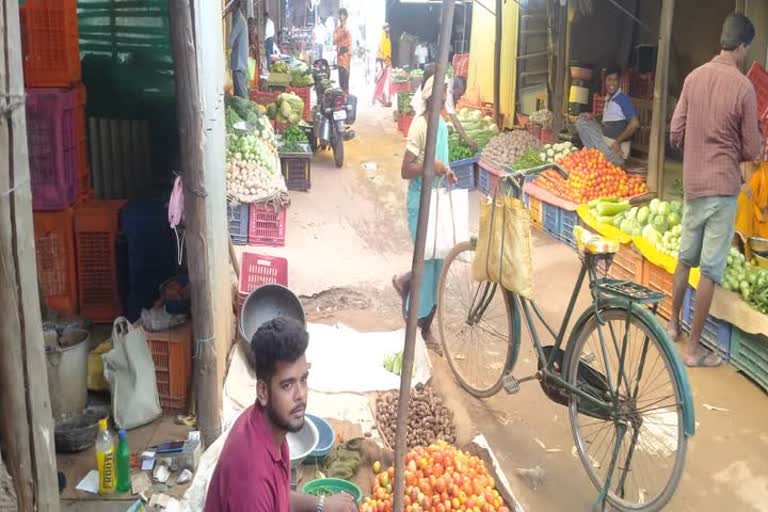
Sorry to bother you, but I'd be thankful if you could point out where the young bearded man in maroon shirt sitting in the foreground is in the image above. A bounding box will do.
[205,318,357,512]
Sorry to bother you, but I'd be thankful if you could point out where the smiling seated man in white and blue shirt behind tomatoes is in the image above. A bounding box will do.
[576,69,640,165]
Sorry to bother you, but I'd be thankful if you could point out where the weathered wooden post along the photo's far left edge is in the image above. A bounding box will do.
[0,0,59,512]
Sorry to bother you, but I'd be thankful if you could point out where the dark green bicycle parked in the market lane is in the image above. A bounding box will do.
[437,165,695,511]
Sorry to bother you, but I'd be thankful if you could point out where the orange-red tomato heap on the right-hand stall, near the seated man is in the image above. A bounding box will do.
[535,148,648,204]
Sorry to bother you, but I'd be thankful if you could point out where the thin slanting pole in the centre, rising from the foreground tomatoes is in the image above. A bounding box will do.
[394,0,455,512]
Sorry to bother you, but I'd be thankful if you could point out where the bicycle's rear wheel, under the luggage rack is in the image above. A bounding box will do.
[565,307,688,511]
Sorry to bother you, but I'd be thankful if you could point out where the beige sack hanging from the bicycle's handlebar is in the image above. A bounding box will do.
[472,183,533,299]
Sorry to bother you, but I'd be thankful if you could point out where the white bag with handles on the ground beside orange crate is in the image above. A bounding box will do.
[101,317,163,430]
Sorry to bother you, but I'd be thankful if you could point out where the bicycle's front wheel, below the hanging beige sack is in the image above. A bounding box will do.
[437,241,520,398]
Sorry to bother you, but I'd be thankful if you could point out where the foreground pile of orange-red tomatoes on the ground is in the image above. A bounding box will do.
[360,441,509,512]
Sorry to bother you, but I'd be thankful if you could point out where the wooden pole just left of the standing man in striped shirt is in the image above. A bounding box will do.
[648,0,675,194]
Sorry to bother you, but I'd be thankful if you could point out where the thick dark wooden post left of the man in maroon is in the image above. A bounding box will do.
[168,0,223,446]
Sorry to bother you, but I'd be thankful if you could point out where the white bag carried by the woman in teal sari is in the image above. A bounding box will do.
[424,186,469,260]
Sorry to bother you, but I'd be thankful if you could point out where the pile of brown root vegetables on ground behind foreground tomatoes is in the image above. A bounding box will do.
[376,384,456,448]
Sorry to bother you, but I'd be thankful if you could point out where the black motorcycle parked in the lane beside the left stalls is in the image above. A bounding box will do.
[311,59,357,168]
